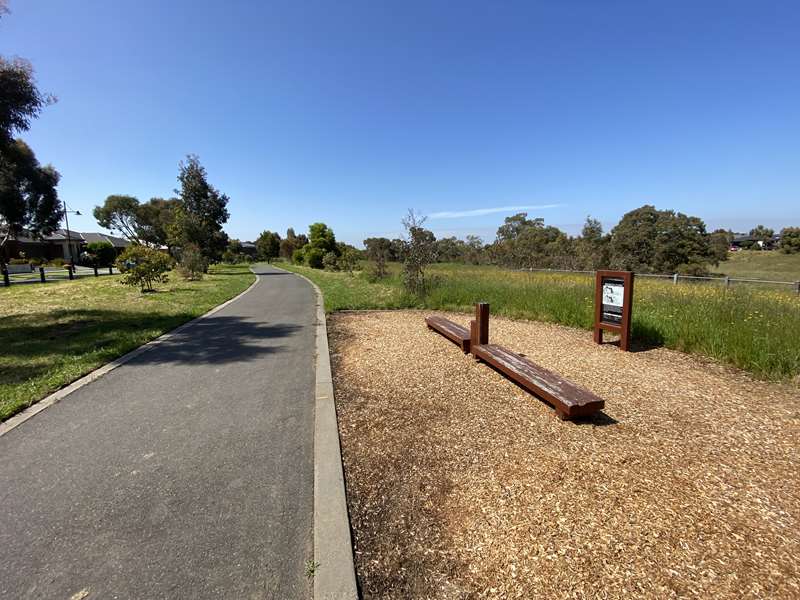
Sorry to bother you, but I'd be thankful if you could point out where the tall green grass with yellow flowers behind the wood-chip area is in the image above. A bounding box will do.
[280,264,800,380]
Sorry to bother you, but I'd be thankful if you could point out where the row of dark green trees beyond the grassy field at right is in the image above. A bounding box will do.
[364,205,800,275]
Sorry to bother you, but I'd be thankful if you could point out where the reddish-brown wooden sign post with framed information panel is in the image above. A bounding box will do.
[594,271,633,351]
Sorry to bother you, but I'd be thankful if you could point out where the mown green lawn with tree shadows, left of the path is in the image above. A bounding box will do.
[0,265,255,421]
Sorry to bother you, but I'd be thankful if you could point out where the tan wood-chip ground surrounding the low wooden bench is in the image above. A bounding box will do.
[329,311,800,598]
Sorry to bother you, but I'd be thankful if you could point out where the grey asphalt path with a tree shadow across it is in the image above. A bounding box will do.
[0,267,315,600]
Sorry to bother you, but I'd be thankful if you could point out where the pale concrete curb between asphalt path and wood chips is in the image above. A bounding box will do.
[273,265,359,600]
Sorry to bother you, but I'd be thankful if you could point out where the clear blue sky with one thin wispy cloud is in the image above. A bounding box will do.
[0,0,800,242]
